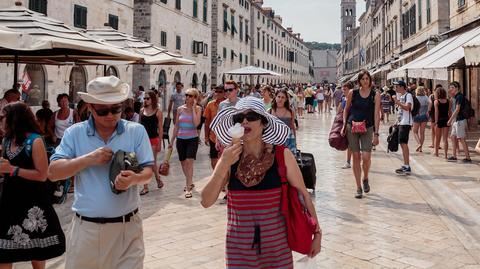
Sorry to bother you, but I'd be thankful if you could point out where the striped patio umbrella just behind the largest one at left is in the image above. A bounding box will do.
[85,28,195,65]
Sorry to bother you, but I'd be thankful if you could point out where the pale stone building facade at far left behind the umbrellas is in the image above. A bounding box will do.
[0,0,133,108]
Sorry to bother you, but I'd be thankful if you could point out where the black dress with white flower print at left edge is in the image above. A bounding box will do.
[0,135,65,263]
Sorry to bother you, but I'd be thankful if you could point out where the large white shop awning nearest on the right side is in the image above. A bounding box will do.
[389,27,480,80]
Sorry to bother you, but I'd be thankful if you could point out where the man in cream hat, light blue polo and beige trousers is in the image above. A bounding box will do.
[48,76,153,269]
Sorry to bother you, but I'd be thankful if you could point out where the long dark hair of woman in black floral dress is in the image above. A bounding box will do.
[3,102,41,146]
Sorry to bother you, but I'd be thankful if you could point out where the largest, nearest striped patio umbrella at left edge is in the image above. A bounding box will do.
[0,6,143,87]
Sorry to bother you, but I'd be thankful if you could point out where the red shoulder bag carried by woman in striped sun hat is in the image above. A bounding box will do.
[275,146,317,255]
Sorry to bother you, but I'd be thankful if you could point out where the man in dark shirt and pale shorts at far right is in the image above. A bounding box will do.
[448,81,472,163]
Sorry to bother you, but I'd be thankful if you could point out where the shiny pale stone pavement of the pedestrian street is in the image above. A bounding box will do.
[15,112,480,269]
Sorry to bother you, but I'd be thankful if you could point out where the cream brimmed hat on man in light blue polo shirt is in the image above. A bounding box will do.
[78,76,130,105]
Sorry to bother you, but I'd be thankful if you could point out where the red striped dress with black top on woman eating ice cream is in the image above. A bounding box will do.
[226,157,293,269]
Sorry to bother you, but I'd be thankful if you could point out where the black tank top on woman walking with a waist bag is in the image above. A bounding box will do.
[348,90,375,128]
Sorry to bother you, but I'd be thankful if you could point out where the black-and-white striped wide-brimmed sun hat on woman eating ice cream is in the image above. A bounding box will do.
[210,96,290,145]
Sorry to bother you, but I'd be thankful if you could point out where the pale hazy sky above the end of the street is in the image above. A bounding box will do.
[264,0,365,43]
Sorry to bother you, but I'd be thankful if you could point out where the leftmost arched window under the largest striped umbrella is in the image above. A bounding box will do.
[22,64,46,106]
